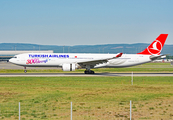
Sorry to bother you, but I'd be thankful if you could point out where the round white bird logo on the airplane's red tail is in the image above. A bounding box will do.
[147,40,162,54]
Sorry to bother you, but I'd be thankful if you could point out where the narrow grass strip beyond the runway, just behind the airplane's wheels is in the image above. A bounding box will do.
[0,63,173,73]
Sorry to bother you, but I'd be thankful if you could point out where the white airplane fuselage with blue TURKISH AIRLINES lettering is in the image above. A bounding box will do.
[10,53,151,68]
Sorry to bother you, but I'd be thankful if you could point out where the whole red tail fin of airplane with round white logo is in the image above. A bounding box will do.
[137,34,168,55]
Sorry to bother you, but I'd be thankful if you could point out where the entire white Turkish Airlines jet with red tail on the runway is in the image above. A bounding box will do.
[9,34,168,74]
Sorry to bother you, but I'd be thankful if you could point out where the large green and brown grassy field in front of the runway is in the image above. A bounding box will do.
[0,77,173,120]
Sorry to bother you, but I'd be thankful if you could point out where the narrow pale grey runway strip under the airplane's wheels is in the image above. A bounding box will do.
[0,73,173,77]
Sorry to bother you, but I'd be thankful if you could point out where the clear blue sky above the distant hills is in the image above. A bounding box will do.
[0,0,173,46]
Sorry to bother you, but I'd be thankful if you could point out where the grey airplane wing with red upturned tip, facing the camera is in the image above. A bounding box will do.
[78,53,123,68]
